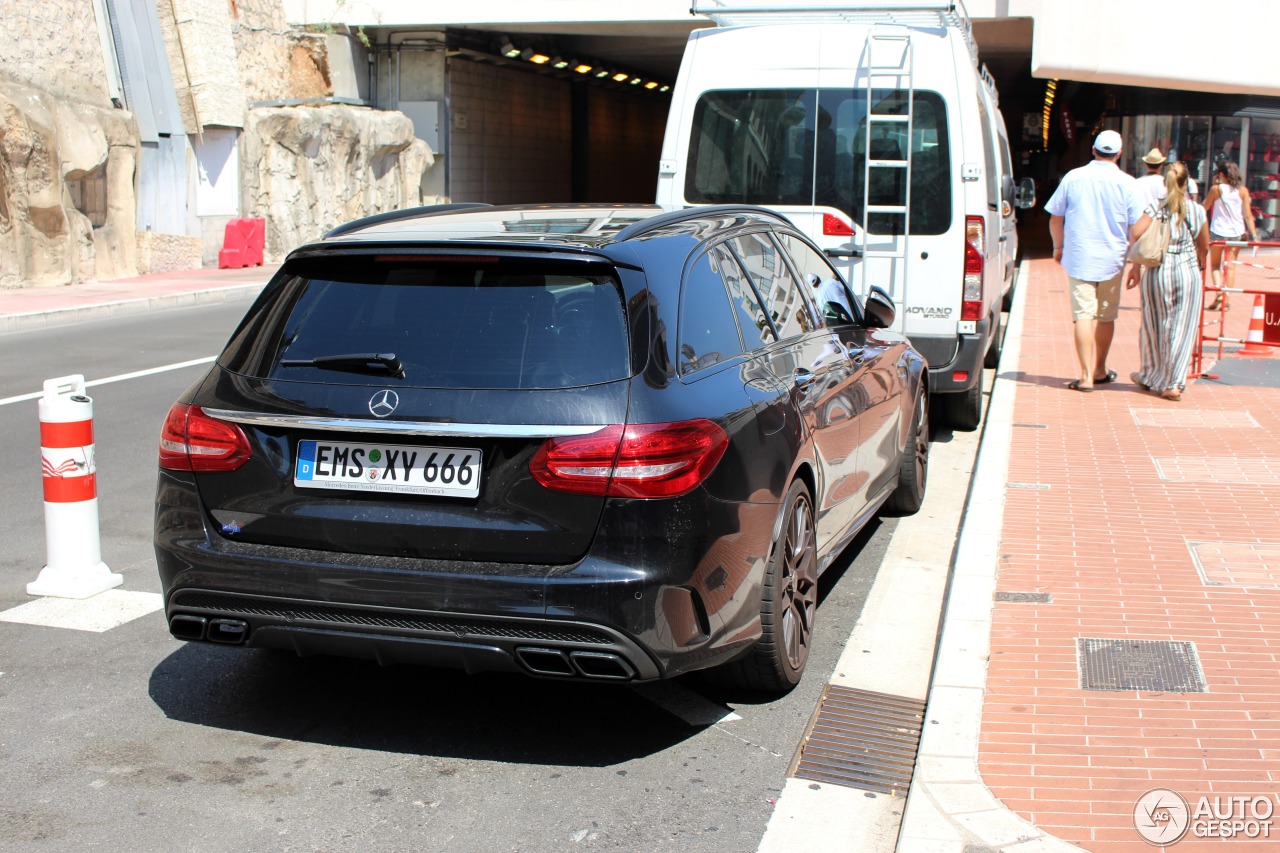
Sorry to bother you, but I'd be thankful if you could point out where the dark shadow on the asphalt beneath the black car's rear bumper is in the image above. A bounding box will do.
[148,644,703,767]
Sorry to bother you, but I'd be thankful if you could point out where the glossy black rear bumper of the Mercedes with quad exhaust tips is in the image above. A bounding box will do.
[155,473,777,681]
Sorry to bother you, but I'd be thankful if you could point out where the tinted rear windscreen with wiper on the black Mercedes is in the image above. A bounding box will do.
[220,256,630,389]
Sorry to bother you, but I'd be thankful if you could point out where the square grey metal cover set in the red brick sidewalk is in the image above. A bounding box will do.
[1079,637,1208,693]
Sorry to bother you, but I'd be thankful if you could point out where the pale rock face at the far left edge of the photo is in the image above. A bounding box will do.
[0,81,138,287]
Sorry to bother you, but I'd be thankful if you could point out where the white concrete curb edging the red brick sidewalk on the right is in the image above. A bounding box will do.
[897,263,1080,853]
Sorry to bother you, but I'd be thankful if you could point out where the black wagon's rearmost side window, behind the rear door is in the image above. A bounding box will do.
[676,252,742,375]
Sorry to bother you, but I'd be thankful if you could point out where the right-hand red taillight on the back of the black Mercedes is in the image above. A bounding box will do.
[529,420,728,498]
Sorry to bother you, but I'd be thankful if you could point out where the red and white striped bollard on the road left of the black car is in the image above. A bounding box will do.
[27,375,124,598]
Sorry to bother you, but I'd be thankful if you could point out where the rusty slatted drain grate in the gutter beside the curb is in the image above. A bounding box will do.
[788,684,924,795]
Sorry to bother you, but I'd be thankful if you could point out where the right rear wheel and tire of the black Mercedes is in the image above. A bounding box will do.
[708,480,818,693]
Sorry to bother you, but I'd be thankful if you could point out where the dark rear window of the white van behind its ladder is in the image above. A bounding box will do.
[685,88,951,234]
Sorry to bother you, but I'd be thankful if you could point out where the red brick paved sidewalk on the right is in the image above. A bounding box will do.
[979,260,1280,852]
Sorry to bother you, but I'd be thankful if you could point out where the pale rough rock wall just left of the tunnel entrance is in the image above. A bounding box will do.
[241,105,434,261]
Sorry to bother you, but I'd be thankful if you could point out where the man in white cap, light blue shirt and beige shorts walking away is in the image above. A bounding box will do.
[1044,131,1143,392]
